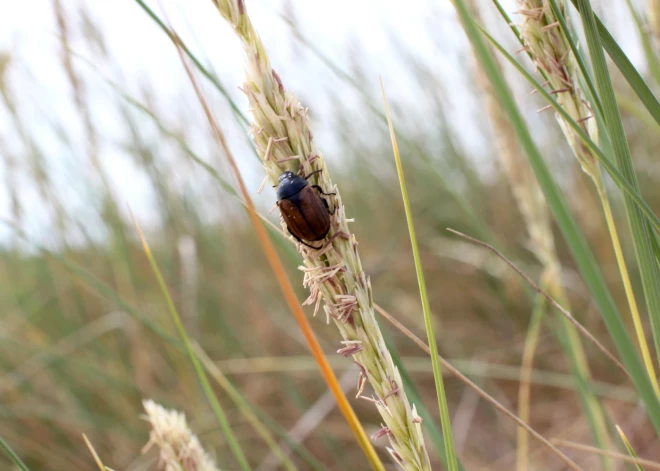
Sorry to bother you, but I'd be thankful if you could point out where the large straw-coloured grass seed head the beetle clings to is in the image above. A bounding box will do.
[208,0,430,470]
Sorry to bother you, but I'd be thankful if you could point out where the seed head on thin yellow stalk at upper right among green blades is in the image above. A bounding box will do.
[518,0,660,395]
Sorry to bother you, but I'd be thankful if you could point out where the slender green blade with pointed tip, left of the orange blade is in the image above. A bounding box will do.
[134,219,250,471]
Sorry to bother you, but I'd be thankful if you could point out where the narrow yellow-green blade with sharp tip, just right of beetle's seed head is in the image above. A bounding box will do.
[380,80,458,471]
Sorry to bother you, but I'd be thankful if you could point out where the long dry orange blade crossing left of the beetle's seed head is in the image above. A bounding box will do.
[162,14,384,470]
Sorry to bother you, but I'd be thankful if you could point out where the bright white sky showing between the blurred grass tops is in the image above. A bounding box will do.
[0,0,638,249]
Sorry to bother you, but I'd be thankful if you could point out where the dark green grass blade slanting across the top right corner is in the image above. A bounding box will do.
[571,0,660,125]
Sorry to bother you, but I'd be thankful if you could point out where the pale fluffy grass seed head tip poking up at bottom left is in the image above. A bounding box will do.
[143,399,218,471]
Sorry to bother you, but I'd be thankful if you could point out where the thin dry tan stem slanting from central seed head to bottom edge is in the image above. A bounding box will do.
[374,304,582,470]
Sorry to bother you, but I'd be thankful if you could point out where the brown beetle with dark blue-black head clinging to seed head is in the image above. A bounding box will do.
[277,170,336,250]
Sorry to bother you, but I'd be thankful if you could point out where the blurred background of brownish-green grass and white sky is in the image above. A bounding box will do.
[0,0,660,470]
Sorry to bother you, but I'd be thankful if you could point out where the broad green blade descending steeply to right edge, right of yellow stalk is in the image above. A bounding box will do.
[578,0,660,402]
